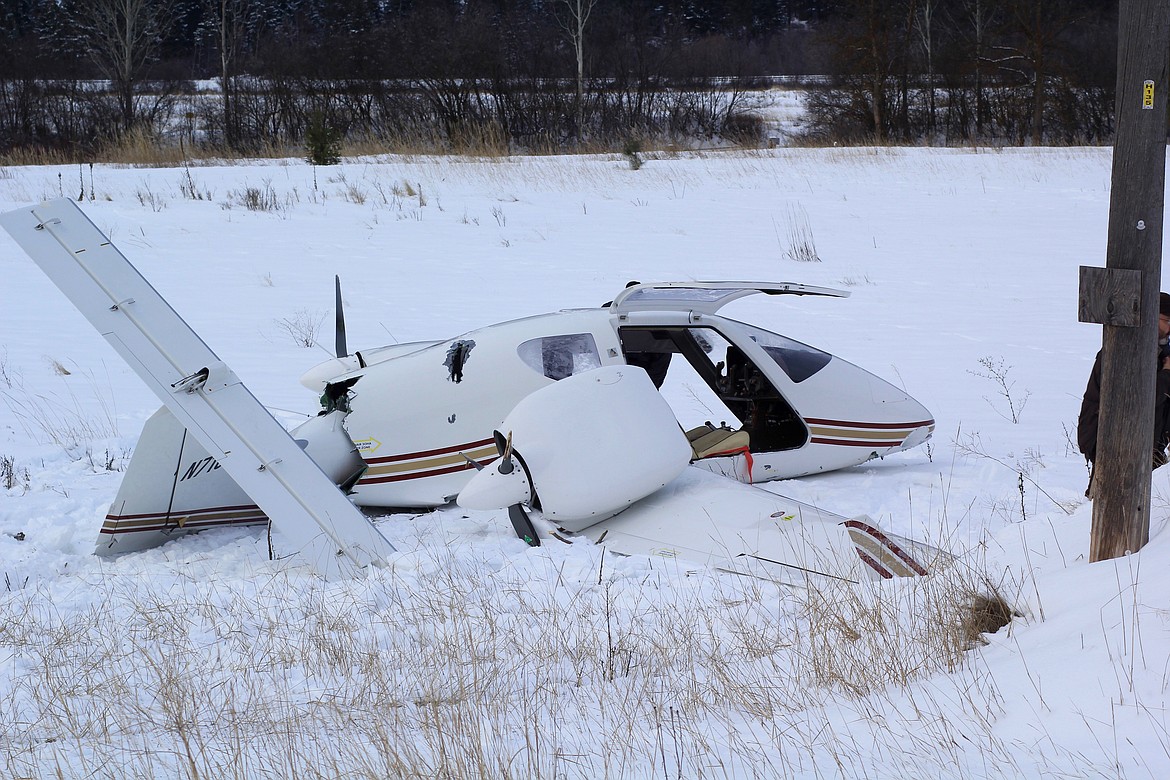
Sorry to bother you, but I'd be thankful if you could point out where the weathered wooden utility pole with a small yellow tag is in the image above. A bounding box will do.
[1080,0,1170,561]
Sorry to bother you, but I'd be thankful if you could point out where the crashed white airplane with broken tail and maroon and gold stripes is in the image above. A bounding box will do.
[0,200,937,581]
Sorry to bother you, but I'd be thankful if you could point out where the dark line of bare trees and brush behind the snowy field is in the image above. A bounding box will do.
[0,0,1116,154]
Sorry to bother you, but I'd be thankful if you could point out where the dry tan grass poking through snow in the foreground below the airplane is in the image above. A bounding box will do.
[0,533,1043,779]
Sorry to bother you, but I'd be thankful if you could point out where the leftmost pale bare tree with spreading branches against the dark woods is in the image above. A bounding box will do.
[70,0,174,131]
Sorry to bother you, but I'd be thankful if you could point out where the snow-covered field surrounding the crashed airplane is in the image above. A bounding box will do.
[0,149,1170,780]
